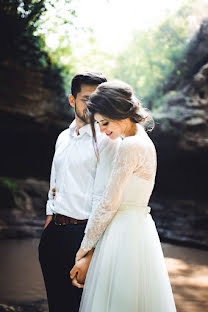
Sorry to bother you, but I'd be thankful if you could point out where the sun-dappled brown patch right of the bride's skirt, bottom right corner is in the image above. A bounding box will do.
[163,244,208,312]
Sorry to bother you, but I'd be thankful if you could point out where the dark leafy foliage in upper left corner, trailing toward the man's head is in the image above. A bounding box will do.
[0,0,76,106]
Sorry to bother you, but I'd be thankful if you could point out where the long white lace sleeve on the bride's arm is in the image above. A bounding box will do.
[81,137,144,251]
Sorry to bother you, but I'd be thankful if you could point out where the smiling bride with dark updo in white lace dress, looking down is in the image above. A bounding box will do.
[71,82,176,312]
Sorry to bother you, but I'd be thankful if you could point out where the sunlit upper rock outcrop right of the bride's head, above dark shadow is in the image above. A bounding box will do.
[154,63,208,151]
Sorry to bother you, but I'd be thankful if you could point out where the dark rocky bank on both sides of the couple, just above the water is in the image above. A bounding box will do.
[0,200,208,250]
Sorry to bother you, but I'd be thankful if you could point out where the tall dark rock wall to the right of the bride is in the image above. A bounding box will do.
[151,21,208,248]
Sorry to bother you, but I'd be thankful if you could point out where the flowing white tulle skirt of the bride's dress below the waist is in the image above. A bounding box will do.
[79,207,176,312]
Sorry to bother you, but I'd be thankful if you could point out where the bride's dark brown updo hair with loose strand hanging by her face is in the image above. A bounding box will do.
[86,81,154,147]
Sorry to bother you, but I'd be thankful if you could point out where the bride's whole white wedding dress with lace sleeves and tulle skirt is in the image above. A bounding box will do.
[80,125,176,312]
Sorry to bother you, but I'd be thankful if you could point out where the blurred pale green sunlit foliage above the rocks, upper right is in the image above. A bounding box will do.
[113,0,206,109]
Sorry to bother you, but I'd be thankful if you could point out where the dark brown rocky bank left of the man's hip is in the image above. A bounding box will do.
[0,178,49,238]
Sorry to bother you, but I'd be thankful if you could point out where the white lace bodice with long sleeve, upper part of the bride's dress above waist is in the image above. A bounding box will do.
[81,125,156,251]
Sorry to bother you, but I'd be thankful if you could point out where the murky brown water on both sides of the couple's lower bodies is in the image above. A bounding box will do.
[0,239,208,312]
